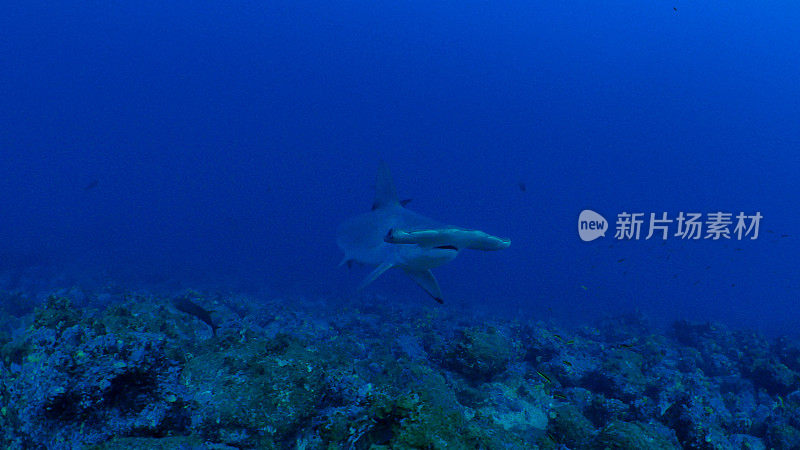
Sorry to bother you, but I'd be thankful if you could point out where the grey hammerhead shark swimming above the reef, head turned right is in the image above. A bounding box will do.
[336,162,511,303]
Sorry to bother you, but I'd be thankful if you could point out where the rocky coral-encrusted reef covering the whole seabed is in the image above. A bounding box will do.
[0,288,800,449]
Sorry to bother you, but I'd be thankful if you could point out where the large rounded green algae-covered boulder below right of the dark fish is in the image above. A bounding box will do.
[180,343,326,448]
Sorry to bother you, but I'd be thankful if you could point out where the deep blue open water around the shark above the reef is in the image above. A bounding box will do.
[0,0,800,333]
